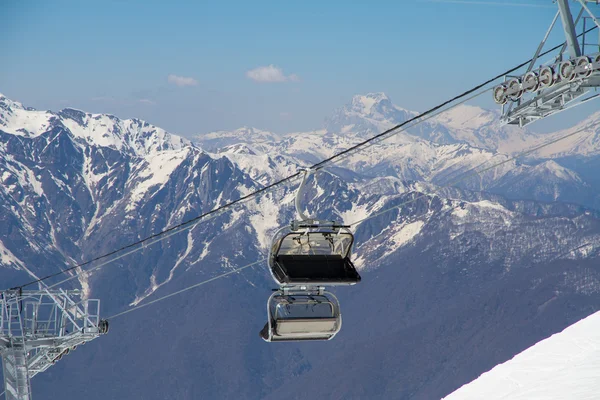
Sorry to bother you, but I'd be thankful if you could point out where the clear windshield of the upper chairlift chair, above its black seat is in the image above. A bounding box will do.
[276,232,354,258]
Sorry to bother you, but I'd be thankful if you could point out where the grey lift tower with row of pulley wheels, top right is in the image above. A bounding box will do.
[493,0,600,126]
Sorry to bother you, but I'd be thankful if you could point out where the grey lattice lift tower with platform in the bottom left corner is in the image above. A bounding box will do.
[0,289,108,400]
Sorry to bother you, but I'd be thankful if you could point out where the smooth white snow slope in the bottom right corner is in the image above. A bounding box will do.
[444,312,600,400]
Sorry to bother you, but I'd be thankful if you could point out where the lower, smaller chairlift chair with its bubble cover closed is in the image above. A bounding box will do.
[260,288,342,342]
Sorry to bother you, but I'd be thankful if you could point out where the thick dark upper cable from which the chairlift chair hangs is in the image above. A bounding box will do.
[10,22,597,288]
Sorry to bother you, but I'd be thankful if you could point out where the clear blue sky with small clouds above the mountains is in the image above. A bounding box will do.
[0,0,598,135]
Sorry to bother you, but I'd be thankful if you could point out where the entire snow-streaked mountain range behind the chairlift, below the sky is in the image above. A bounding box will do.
[0,94,600,400]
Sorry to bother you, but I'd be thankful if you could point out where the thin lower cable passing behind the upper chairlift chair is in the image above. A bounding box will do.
[107,118,600,320]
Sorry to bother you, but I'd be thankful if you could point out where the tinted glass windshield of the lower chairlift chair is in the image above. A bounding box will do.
[271,296,335,320]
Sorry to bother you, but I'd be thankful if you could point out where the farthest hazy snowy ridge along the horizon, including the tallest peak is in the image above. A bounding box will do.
[194,93,600,159]
